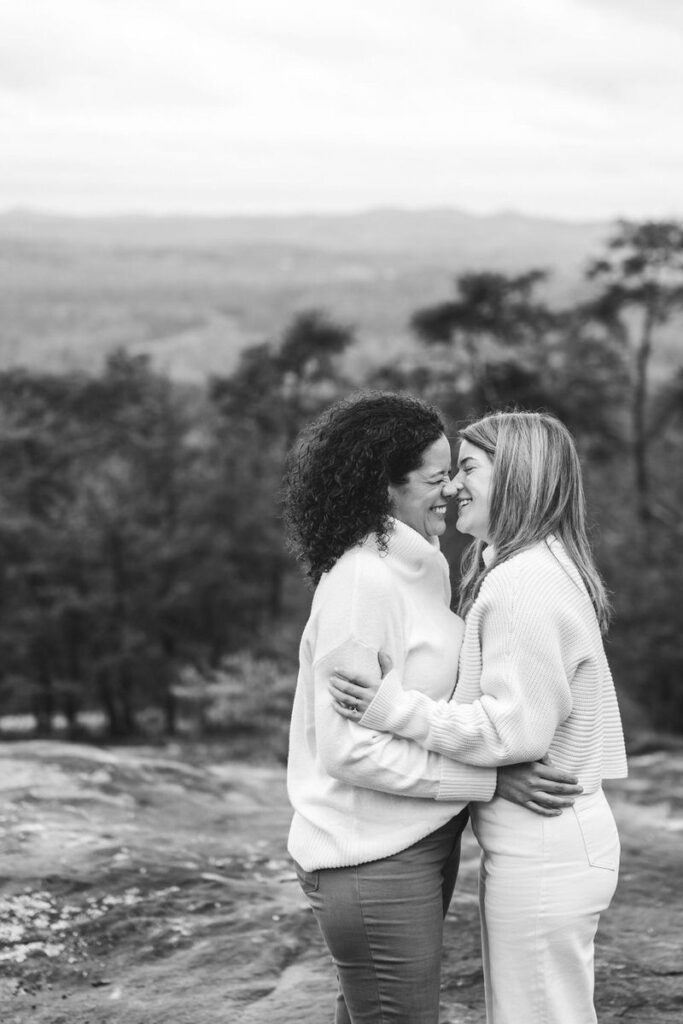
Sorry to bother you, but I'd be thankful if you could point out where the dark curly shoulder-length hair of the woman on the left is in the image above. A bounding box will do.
[283,391,445,584]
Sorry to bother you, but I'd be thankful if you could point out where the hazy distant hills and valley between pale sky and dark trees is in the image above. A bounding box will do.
[0,208,610,380]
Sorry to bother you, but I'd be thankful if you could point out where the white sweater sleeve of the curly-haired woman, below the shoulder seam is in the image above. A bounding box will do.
[313,638,496,802]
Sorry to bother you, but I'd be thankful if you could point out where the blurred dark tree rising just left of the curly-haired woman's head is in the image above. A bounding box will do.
[209,310,353,621]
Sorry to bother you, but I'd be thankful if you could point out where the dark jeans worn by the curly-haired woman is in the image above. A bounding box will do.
[296,810,468,1024]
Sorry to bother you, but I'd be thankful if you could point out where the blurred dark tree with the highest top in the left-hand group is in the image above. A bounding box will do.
[76,352,205,734]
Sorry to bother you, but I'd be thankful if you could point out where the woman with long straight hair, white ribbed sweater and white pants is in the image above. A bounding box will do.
[331,412,627,1024]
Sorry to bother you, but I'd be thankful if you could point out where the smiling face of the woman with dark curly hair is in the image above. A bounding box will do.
[389,434,455,540]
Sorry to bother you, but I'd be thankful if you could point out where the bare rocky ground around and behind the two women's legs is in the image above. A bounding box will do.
[0,741,683,1024]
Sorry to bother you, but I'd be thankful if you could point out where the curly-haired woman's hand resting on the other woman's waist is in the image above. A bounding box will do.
[496,755,584,817]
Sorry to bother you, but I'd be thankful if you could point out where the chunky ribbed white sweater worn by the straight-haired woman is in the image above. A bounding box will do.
[361,538,627,794]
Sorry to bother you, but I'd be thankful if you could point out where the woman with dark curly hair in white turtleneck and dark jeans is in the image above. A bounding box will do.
[285,392,578,1024]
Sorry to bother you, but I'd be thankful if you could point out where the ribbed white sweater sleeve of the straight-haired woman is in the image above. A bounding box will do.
[360,573,571,765]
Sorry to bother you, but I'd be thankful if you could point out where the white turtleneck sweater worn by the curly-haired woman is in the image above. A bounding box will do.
[288,521,496,871]
